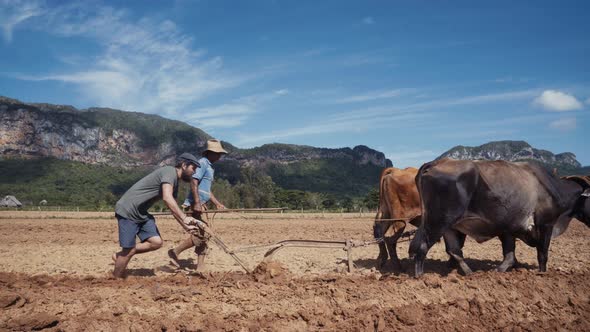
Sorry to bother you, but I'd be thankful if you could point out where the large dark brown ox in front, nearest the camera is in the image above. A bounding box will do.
[409,159,590,276]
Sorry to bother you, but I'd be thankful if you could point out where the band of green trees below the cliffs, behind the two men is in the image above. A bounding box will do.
[0,158,379,211]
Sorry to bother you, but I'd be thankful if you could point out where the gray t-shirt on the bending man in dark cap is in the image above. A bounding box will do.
[115,166,178,222]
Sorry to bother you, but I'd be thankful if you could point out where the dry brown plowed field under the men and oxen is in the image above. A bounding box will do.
[0,211,590,331]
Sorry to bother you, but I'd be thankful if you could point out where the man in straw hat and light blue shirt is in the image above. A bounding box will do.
[168,139,227,270]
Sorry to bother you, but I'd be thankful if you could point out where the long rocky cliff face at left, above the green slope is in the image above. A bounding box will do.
[0,98,209,168]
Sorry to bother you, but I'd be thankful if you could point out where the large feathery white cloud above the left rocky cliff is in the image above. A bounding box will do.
[9,3,246,117]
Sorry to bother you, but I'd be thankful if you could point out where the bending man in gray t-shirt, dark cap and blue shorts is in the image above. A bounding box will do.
[113,153,206,278]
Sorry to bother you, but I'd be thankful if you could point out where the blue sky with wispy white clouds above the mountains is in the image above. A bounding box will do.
[0,0,590,167]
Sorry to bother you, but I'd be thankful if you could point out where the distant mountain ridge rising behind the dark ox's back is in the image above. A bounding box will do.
[437,141,590,175]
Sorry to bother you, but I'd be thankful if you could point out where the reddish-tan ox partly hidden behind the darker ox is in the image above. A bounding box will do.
[373,167,420,269]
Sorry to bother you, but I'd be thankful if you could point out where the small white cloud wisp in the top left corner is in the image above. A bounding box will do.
[0,0,43,43]
